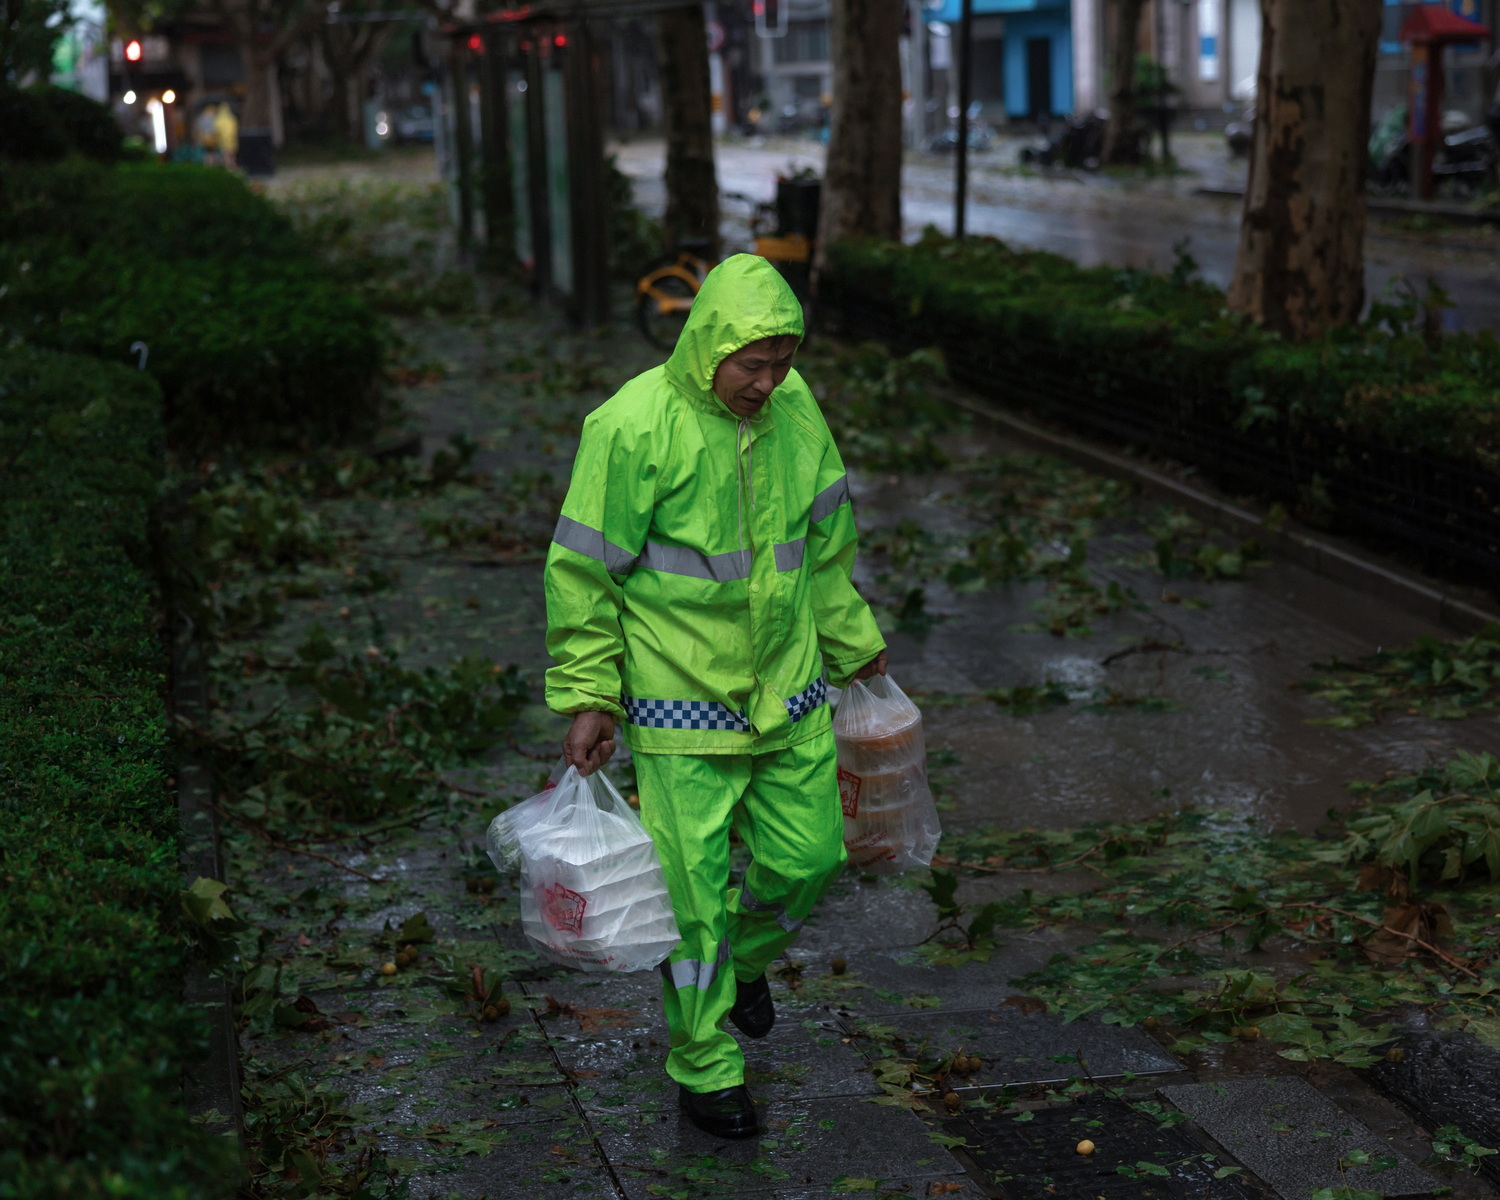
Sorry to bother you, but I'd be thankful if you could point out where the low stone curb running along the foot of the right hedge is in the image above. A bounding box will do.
[950,395,1500,635]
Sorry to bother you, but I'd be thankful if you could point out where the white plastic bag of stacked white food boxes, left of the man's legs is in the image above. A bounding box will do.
[488,767,680,971]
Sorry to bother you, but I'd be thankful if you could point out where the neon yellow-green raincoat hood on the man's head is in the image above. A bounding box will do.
[666,254,803,414]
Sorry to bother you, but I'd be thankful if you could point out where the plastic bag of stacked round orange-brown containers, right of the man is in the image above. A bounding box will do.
[834,675,942,875]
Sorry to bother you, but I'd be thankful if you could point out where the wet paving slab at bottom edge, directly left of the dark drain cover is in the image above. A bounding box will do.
[594,1097,974,1200]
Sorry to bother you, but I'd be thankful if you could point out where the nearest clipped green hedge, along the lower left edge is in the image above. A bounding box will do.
[0,347,234,1200]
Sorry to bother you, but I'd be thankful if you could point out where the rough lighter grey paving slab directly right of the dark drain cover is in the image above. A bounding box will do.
[1160,1076,1439,1200]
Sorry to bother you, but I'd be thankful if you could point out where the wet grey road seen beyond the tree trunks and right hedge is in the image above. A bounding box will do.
[614,137,1500,330]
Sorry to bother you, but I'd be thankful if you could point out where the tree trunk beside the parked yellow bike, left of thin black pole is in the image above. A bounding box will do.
[815,0,902,270]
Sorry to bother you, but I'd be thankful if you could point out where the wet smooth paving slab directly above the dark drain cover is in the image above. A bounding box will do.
[858,1005,1182,1088]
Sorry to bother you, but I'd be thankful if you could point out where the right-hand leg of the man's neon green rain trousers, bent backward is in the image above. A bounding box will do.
[729,731,846,980]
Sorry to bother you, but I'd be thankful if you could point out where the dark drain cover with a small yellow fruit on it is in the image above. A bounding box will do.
[951,1098,1263,1200]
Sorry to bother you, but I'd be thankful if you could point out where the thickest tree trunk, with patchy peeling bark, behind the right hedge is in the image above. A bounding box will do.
[1229,0,1382,339]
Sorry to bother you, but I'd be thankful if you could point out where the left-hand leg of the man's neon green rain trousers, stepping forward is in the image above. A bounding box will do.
[636,755,750,1092]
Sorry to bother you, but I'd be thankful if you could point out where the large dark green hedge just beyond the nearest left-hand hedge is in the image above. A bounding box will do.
[0,161,384,443]
